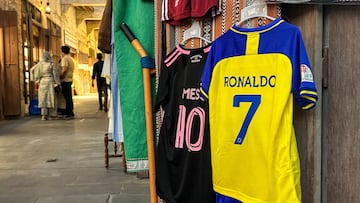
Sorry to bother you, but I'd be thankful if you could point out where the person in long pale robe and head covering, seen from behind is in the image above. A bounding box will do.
[34,51,60,120]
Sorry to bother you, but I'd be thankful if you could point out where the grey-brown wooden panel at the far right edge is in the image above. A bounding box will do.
[323,5,360,203]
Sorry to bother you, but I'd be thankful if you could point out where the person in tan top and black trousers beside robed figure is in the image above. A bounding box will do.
[60,45,75,119]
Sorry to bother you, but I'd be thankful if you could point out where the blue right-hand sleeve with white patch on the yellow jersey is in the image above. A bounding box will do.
[293,31,318,109]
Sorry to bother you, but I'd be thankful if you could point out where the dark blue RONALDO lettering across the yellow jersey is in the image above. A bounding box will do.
[224,75,276,87]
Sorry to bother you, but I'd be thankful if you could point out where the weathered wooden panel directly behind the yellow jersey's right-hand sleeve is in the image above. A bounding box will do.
[282,4,322,203]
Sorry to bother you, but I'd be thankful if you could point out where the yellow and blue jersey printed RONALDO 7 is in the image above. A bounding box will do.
[201,18,317,203]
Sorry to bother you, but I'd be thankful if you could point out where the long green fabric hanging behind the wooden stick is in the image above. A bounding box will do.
[113,0,154,172]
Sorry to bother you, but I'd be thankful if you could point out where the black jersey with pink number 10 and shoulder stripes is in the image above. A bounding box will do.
[155,46,215,203]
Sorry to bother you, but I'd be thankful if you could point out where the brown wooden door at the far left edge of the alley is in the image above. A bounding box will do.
[0,11,21,118]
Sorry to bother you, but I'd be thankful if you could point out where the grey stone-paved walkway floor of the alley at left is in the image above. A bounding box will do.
[0,95,150,203]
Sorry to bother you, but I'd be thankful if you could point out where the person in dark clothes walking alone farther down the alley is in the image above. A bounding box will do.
[91,53,108,112]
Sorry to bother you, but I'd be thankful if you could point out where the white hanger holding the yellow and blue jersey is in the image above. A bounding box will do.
[236,0,275,26]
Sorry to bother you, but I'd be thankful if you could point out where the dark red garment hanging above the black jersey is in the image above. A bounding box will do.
[161,0,221,25]
